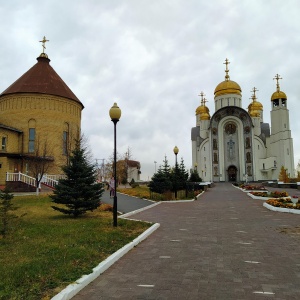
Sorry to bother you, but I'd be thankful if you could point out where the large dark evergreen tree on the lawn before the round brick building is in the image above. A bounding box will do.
[50,141,104,217]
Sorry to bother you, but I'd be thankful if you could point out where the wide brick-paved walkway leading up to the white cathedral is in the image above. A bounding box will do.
[73,183,300,300]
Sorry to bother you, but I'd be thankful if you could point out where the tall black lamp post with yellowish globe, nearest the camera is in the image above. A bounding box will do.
[109,102,121,227]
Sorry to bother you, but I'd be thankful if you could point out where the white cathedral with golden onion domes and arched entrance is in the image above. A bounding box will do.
[191,59,294,182]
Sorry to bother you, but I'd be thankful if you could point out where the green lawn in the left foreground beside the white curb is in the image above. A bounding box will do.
[0,196,151,300]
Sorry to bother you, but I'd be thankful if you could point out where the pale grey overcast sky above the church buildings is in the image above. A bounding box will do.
[0,0,300,180]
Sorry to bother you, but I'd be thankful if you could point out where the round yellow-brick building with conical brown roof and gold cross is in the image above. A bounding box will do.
[0,38,84,185]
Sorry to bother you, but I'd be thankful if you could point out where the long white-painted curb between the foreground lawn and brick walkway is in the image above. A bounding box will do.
[51,223,160,300]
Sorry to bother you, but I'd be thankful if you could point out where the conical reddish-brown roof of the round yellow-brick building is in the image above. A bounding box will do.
[0,56,83,107]
